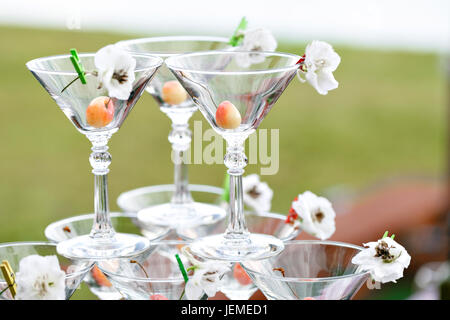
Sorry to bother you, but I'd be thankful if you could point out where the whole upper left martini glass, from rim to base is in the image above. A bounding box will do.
[27,53,163,260]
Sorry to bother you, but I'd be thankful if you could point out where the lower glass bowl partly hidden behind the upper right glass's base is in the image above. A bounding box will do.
[178,212,300,300]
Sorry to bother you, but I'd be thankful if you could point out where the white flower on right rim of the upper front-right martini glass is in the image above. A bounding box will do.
[297,40,341,95]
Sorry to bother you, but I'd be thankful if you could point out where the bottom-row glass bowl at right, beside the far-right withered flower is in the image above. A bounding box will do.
[242,240,369,300]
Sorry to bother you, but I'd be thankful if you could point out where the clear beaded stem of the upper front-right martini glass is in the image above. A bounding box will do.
[224,136,249,240]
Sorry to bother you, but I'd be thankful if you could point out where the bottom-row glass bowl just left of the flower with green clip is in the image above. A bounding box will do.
[98,241,194,300]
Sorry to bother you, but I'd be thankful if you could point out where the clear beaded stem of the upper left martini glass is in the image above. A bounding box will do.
[88,134,115,239]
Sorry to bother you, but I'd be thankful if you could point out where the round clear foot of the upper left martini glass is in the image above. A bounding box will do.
[57,233,150,260]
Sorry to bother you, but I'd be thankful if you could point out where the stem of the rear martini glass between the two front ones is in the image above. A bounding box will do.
[169,117,192,204]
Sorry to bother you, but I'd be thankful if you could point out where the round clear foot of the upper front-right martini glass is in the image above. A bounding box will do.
[189,234,284,262]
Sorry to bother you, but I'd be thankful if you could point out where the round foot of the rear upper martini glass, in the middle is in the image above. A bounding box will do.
[137,202,226,229]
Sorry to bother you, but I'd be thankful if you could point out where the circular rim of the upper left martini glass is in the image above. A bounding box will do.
[25,51,164,76]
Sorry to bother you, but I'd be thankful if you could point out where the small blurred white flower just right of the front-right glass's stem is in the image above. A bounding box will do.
[242,174,273,213]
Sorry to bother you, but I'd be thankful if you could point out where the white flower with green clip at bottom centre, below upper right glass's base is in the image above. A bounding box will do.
[182,247,230,300]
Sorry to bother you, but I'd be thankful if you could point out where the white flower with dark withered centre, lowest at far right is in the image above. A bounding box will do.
[352,237,411,283]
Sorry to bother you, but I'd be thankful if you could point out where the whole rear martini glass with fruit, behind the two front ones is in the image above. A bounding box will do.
[118,36,230,228]
